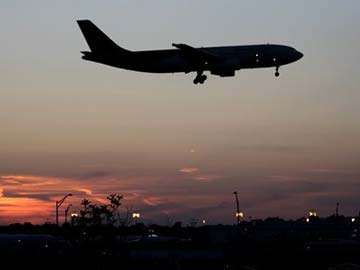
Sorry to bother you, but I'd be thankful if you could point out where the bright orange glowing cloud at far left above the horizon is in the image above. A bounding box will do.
[0,175,136,224]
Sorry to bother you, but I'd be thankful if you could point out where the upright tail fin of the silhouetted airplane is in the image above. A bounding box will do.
[77,20,129,53]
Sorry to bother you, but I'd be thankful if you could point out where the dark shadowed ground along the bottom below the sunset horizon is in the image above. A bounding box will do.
[0,219,360,270]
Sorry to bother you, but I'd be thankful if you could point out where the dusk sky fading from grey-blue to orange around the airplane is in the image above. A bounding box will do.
[0,0,360,224]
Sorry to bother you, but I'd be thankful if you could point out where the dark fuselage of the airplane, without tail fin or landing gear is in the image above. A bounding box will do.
[83,44,303,75]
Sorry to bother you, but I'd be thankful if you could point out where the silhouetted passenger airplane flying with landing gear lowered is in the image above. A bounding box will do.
[77,20,303,84]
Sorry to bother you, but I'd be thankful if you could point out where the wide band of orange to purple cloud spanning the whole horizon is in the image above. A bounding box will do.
[0,167,360,224]
